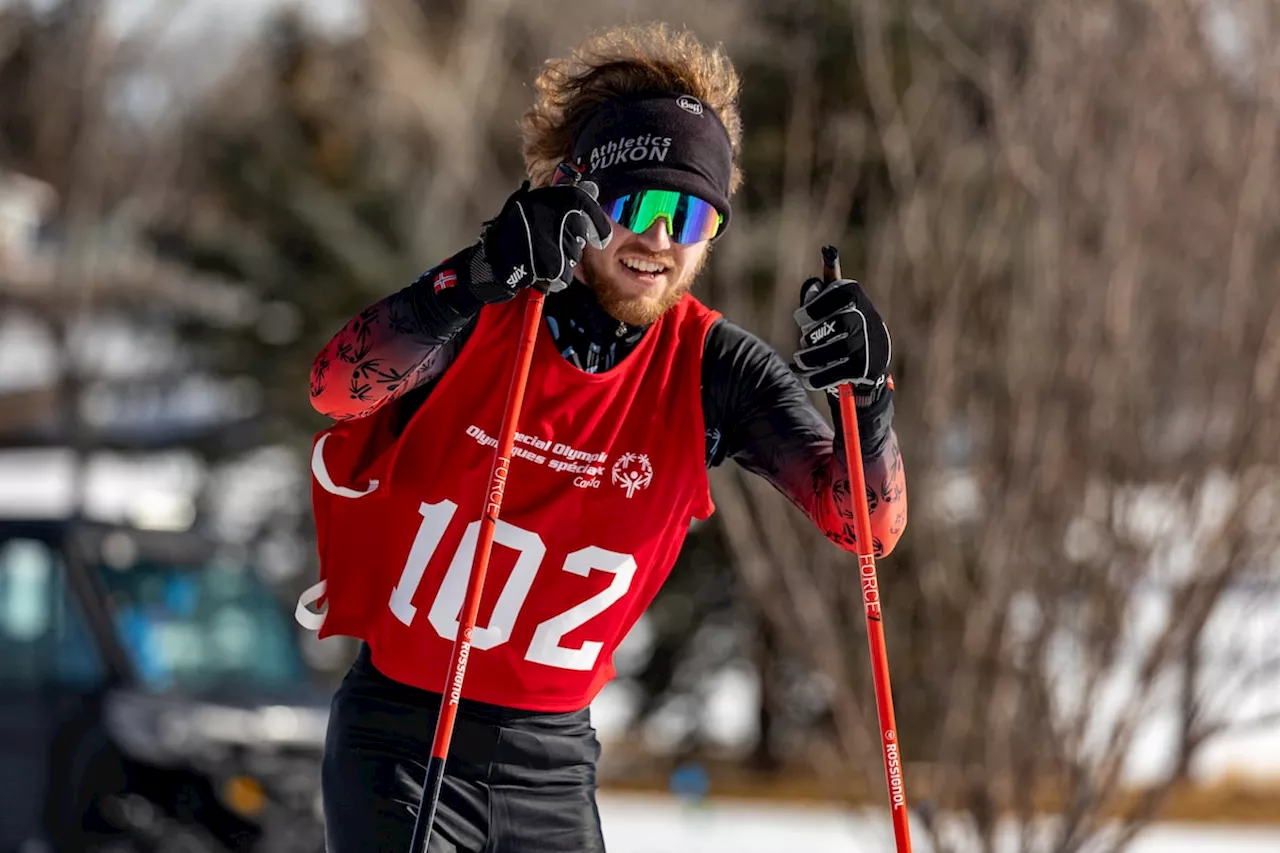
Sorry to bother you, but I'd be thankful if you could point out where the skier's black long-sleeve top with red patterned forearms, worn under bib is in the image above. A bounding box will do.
[311,252,906,555]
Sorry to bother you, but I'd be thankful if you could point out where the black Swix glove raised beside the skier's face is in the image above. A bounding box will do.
[467,181,613,302]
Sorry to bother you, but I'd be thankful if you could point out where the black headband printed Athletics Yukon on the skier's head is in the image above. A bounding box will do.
[573,92,733,233]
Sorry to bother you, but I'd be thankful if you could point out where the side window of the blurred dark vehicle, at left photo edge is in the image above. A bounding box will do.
[0,539,106,689]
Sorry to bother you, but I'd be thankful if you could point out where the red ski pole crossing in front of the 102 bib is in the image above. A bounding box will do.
[410,287,545,853]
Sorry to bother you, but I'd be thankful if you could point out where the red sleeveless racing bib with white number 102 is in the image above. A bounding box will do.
[298,296,719,711]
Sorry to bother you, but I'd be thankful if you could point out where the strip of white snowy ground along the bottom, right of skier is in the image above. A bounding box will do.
[600,794,1280,853]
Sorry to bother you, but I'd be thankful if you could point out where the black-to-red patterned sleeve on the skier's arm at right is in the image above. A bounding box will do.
[703,320,906,556]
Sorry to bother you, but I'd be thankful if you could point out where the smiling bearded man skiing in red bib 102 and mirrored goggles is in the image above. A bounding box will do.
[303,19,906,853]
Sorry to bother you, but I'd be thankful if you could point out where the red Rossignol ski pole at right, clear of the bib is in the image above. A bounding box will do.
[822,246,911,853]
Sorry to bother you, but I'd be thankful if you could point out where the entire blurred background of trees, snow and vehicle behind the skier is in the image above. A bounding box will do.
[0,0,1280,853]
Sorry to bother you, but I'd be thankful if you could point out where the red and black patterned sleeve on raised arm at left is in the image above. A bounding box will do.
[311,262,479,420]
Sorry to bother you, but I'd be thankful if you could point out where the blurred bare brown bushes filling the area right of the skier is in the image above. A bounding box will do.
[712,0,1280,850]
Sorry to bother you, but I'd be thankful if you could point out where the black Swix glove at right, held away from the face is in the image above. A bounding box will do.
[792,278,893,407]
